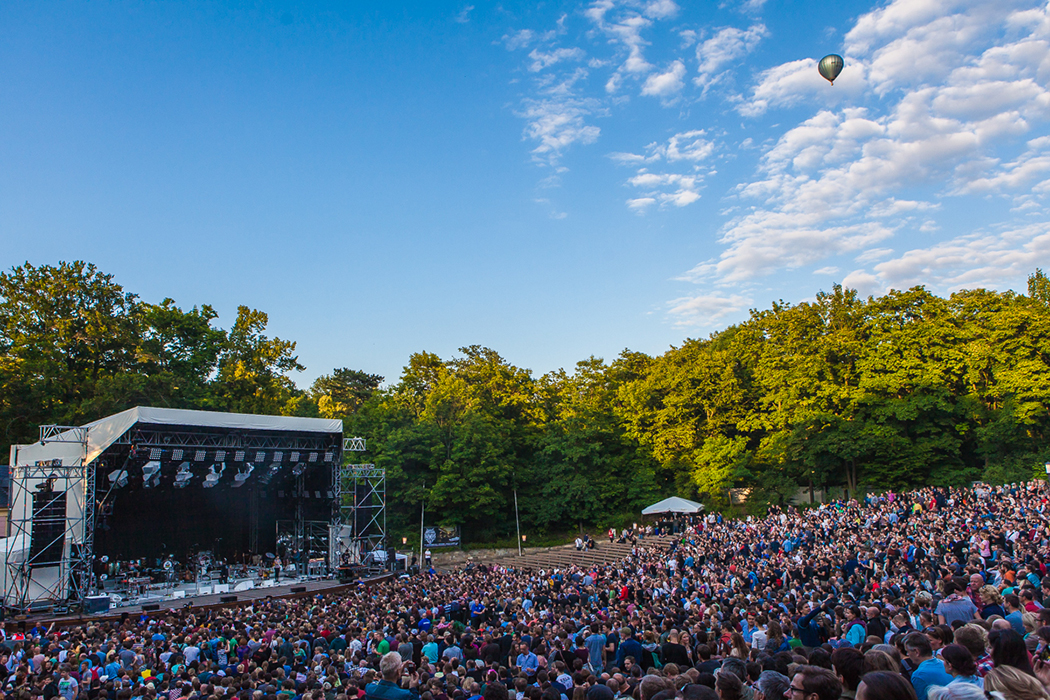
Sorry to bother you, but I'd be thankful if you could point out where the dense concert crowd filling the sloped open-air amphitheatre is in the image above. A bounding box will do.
[0,482,1050,700]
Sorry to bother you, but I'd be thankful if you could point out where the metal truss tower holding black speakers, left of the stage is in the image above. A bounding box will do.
[4,425,95,614]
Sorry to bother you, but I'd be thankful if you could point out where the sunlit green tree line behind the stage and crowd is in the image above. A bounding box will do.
[0,261,1050,540]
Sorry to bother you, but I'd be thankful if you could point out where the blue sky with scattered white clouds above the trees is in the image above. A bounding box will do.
[0,0,1050,385]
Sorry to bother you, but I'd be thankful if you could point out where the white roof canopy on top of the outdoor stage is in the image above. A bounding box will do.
[12,406,342,465]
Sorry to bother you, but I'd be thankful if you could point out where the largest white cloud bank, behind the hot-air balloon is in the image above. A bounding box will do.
[713,0,1050,290]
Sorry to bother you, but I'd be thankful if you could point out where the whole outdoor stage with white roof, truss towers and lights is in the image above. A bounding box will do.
[0,407,386,616]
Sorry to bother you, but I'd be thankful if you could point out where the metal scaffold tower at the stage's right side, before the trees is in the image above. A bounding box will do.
[339,461,386,558]
